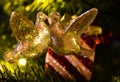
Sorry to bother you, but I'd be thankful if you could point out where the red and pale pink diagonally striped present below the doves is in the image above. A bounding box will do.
[45,36,95,81]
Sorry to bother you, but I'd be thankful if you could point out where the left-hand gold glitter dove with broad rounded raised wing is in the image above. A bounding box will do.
[4,11,51,62]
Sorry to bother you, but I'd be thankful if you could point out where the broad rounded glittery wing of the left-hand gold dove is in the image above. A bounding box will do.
[10,11,35,41]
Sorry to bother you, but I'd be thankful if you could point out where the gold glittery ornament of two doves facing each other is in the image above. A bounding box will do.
[4,8,98,62]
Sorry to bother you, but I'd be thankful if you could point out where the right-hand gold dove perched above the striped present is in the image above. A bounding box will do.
[49,8,98,56]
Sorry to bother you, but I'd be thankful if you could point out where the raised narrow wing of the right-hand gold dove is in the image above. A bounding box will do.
[65,8,98,34]
